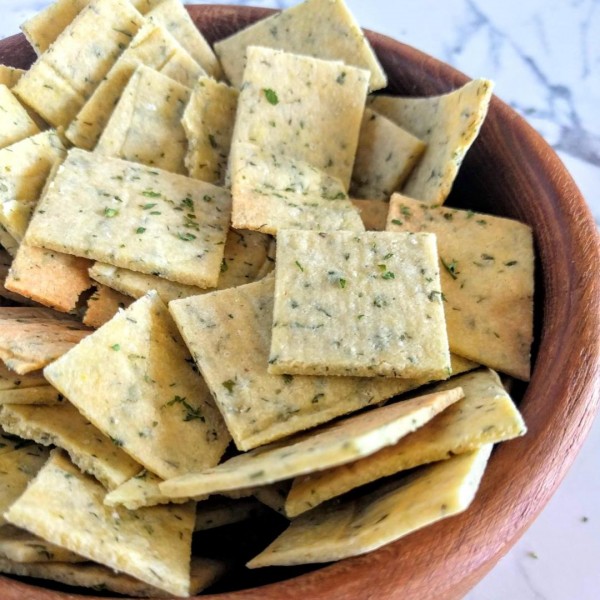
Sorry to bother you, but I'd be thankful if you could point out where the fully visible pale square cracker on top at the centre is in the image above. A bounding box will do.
[269,230,450,379]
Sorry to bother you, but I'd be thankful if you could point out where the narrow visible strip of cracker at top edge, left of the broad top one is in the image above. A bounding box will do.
[145,0,222,79]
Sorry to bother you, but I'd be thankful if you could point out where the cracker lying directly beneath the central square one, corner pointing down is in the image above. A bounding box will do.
[169,277,450,450]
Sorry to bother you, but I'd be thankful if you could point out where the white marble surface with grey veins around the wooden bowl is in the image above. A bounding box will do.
[0,0,600,600]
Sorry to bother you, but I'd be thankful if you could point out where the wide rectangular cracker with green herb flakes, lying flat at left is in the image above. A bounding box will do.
[26,148,231,287]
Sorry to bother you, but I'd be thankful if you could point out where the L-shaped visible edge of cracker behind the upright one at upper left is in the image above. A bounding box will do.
[66,23,204,150]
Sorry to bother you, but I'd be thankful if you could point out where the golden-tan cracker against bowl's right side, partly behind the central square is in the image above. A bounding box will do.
[388,194,534,381]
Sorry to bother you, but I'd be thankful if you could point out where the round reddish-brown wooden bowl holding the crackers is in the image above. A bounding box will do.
[0,5,600,600]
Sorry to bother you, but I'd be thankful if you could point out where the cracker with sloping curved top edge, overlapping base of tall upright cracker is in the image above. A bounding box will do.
[230,144,363,234]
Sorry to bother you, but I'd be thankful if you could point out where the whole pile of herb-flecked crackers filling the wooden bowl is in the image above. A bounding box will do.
[0,0,534,597]
